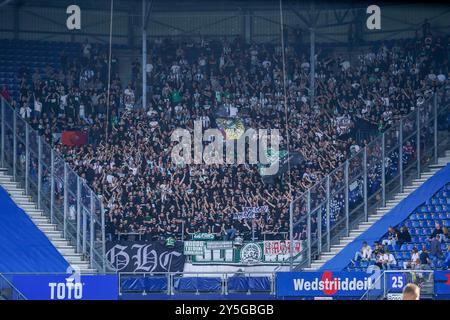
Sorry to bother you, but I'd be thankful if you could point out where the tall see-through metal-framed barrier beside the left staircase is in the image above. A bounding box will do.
[0,98,106,272]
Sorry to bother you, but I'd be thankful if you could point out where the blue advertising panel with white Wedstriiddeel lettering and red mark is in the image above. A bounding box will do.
[276,271,376,298]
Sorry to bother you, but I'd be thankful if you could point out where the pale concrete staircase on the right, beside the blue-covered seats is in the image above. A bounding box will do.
[304,150,450,271]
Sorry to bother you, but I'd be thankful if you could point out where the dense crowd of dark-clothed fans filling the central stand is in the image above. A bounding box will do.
[6,29,450,240]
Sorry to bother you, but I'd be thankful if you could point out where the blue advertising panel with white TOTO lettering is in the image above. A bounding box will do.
[11,274,119,300]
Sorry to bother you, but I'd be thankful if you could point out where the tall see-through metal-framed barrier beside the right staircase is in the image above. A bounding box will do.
[290,90,449,270]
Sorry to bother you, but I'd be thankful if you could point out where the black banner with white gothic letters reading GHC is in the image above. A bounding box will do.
[106,241,186,272]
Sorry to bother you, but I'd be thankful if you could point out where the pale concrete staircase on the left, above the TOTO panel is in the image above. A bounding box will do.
[0,169,97,273]
